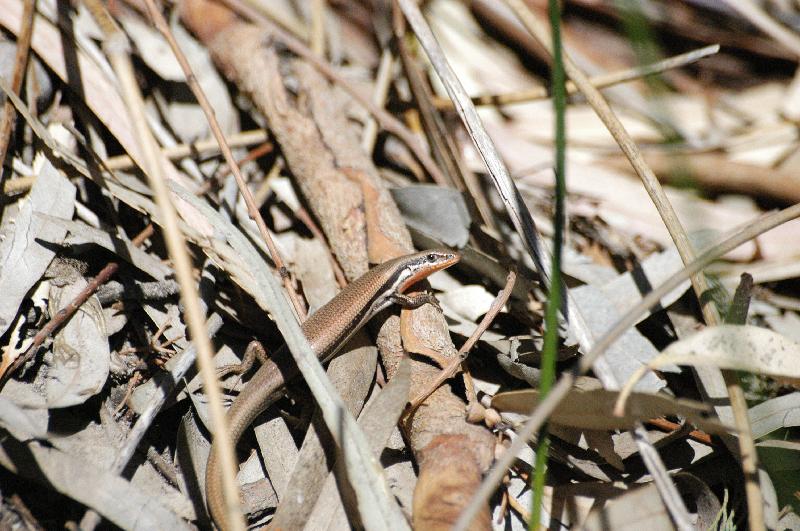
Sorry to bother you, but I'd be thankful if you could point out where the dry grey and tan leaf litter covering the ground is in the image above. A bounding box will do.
[0,0,800,529]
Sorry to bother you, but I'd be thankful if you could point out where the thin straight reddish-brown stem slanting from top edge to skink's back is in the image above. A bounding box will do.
[145,0,305,320]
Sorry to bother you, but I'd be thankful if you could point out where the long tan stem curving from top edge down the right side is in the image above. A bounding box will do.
[506,0,764,531]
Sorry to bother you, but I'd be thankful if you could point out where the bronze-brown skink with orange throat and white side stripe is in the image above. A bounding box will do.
[206,249,460,529]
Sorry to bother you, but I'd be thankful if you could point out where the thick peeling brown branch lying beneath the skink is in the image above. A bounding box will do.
[181,0,494,529]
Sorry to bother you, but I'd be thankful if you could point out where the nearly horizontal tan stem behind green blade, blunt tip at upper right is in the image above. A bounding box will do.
[433,44,719,110]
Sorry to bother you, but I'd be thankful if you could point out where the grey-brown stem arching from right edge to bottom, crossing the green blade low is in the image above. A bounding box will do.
[455,200,800,529]
